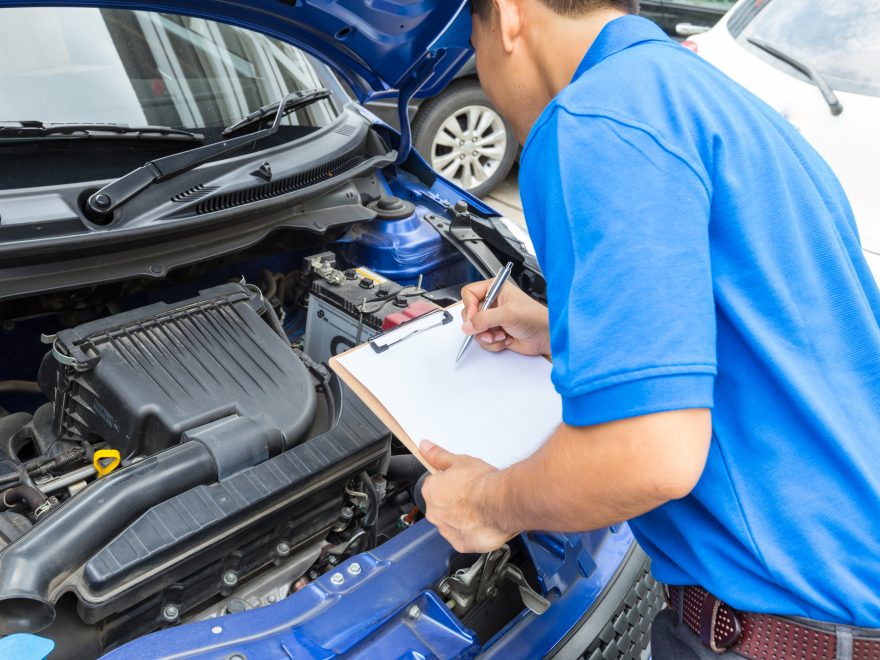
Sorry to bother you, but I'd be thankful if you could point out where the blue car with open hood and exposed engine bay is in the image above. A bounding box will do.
[0,0,662,660]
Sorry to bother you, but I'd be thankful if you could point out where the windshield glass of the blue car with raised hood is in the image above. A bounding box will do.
[0,7,336,129]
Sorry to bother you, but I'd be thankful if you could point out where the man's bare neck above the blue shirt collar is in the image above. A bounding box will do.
[532,9,626,100]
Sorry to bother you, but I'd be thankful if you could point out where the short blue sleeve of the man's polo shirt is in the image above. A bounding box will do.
[520,109,716,426]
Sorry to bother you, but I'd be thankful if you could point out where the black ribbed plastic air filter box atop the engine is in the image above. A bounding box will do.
[39,284,316,457]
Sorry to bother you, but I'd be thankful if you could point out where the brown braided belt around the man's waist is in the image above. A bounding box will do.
[665,586,880,660]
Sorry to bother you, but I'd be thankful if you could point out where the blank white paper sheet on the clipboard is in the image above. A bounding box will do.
[339,305,562,468]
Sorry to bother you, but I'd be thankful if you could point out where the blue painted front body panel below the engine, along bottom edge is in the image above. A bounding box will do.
[105,521,633,660]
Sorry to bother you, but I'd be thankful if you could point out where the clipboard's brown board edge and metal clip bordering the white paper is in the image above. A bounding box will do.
[328,307,453,466]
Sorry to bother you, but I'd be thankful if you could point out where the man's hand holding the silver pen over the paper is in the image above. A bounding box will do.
[461,280,550,355]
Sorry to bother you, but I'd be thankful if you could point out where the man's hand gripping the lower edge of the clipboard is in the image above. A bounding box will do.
[420,440,516,552]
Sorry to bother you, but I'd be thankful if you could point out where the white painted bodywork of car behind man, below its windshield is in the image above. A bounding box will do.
[692,0,880,266]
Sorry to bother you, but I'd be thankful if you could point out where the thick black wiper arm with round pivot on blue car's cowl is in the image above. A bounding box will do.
[86,90,330,217]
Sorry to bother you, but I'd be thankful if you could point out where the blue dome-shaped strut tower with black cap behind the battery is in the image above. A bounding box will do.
[343,197,464,288]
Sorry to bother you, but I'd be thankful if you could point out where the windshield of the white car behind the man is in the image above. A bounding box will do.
[728,0,880,96]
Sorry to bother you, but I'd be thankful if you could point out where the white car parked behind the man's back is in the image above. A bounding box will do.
[686,0,880,281]
